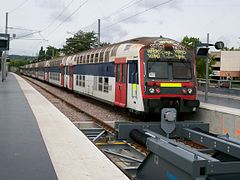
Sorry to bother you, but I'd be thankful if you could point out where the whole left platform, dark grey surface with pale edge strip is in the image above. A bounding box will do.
[0,73,128,180]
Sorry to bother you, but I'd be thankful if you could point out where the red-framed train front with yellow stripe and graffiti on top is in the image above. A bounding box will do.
[140,40,199,113]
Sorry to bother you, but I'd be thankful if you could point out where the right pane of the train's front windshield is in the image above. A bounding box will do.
[173,62,192,79]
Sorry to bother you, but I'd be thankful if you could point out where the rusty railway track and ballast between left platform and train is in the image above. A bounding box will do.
[22,76,148,179]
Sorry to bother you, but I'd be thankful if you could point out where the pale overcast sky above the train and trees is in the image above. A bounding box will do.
[0,0,240,55]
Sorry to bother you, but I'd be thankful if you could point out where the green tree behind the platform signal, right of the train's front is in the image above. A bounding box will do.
[181,36,215,78]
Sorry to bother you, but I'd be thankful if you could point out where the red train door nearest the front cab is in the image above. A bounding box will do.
[114,58,127,107]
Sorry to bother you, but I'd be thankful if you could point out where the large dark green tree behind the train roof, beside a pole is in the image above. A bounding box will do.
[62,31,110,55]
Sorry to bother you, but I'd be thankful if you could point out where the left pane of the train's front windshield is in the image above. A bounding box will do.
[147,61,168,79]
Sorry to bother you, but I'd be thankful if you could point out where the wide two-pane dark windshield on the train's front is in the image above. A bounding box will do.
[147,61,192,79]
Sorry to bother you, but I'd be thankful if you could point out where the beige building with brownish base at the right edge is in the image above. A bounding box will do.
[210,51,240,79]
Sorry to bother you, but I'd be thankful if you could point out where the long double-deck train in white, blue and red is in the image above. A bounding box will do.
[21,37,199,113]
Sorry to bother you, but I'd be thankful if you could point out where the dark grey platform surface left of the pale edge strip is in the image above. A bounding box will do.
[0,74,57,180]
